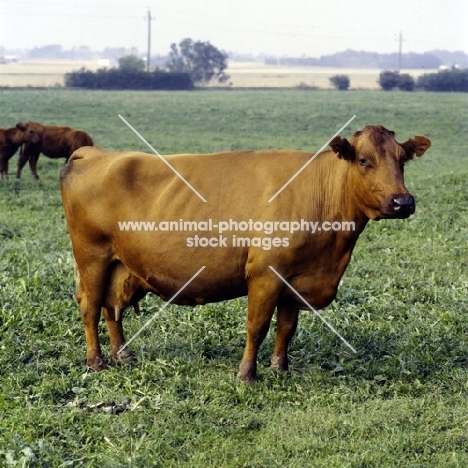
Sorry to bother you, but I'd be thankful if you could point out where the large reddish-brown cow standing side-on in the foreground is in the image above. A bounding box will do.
[61,125,431,382]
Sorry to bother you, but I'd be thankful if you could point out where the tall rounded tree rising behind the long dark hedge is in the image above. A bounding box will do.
[167,39,229,83]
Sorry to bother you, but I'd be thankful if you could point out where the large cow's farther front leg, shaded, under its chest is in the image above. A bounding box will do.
[271,305,299,371]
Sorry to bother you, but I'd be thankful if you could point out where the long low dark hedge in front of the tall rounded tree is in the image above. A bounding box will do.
[65,68,193,90]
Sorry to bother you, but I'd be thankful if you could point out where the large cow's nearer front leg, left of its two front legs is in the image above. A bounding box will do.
[238,278,279,383]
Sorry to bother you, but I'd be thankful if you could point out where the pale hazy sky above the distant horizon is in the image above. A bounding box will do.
[0,0,468,57]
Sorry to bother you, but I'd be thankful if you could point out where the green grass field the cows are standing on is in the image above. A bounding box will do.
[0,90,468,468]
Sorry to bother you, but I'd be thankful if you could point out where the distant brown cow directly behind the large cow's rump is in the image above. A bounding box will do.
[16,122,93,179]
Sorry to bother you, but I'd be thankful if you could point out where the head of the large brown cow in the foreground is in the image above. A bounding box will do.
[330,125,431,220]
